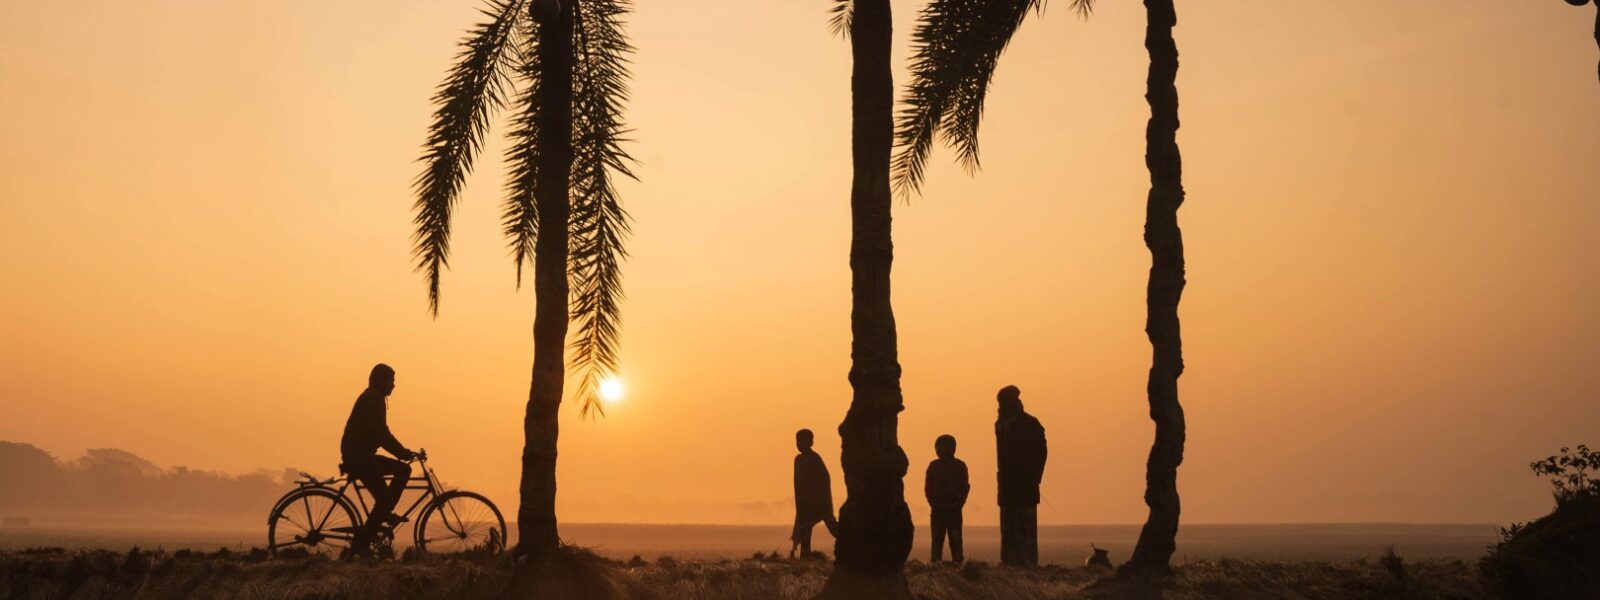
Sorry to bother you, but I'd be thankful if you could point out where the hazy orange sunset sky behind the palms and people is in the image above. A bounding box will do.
[0,0,1600,523]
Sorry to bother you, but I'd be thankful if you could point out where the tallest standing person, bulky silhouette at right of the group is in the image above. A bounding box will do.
[995,386,1050,566]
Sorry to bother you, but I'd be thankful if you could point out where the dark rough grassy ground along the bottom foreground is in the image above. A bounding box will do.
[0,550,1486,600]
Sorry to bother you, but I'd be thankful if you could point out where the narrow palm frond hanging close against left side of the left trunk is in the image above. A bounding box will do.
[501,19,539,290]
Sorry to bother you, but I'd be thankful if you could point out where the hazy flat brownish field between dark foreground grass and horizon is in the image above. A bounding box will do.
[0,522,1496,565]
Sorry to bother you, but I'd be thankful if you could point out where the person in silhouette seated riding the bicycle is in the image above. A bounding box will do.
[339,363,416,555]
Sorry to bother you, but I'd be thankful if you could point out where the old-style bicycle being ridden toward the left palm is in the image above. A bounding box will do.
[267,450,506,558]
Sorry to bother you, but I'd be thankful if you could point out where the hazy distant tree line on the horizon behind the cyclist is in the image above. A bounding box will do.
[0,442,298,517]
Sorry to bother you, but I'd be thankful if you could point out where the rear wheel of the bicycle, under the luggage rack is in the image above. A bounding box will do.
[267,488,362,558]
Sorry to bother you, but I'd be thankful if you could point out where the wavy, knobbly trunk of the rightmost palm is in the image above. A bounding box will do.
[1125,0,1186,571]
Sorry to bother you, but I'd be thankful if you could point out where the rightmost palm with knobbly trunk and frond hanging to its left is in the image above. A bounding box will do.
[894,0,1186,571]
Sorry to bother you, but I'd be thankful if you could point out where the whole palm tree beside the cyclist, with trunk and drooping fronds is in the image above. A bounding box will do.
[413,0,632,557]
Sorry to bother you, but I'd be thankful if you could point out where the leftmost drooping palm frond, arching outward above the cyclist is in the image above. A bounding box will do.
[411,0,522,315]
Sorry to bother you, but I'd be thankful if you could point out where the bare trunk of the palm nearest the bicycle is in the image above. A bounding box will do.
[517,2,573,557]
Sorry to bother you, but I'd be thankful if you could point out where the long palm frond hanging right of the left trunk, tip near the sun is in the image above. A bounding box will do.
[570,0,634,416]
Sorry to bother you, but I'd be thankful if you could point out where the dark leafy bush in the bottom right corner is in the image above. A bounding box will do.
[1478,445,1600,598]
